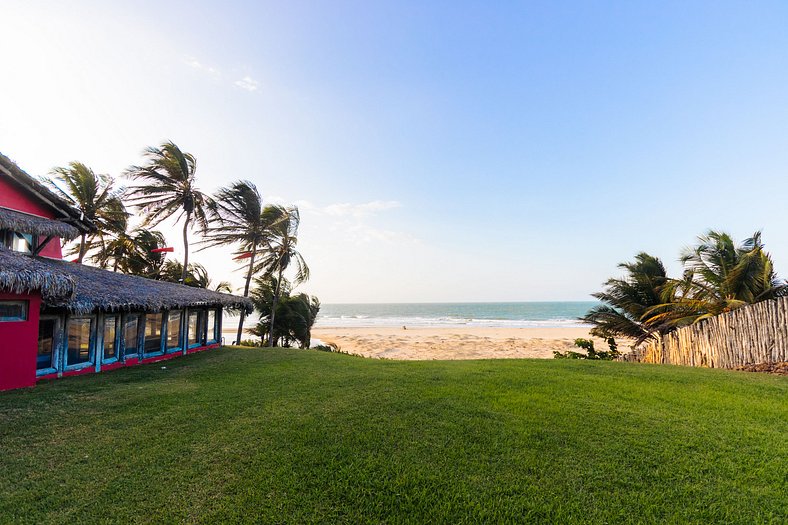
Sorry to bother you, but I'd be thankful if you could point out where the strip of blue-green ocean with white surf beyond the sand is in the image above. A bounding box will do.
[315,301,599,328]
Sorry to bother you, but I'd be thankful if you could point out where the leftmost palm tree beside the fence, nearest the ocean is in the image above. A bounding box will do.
[581,253,671,343]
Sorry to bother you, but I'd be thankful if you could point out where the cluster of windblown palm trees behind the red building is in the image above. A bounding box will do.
[47,142,320,346]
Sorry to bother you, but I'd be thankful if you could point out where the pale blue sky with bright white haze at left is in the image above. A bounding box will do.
[0,0,788,303]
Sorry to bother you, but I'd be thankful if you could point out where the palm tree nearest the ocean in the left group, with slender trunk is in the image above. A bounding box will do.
[258,206,309,347]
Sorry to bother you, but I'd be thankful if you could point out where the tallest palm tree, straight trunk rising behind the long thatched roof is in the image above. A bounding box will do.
[126,142,211,281]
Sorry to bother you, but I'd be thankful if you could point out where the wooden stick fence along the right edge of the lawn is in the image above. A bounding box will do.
[624,297,788,368]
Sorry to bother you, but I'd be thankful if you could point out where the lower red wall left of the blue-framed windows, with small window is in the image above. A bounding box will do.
[0,293,41,390]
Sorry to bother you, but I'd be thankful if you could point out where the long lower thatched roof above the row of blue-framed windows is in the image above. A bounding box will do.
[0,249,252,313]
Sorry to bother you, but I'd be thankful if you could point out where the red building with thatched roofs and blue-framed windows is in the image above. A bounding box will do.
[0,154,251,390]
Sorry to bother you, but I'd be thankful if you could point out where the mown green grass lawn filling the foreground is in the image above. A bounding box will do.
[0,348,788,524]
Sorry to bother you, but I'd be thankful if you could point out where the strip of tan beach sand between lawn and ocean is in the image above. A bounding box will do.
[312,326,626,360]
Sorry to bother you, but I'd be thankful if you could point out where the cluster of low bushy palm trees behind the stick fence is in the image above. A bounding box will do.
[582,231,788,344]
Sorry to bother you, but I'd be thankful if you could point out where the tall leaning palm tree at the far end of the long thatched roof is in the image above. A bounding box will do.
[203,181,281,344]
